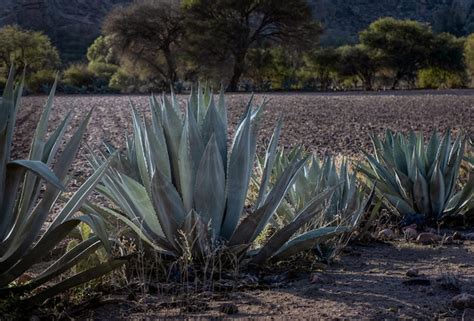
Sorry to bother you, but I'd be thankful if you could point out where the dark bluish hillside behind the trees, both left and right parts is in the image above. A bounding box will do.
[0,0,474,61]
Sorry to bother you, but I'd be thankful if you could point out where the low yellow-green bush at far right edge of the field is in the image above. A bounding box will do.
[418,68,467,89]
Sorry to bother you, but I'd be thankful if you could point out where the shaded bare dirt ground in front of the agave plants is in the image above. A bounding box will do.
[63,241,474,320]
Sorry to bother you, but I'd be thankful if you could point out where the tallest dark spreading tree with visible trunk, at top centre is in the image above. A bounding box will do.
[184,0,321,91]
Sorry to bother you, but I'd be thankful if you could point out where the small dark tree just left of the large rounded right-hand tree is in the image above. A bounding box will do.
[337,45,379,90]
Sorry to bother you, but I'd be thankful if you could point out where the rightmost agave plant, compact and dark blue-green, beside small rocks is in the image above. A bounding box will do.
[359,130,474,223]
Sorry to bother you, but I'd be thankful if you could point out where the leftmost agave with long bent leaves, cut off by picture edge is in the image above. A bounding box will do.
[0,71,123,302]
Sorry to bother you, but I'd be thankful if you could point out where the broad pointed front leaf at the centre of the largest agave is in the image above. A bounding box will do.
[194,135,225,237]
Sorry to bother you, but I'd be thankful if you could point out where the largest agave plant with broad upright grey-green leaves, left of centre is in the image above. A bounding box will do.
[91,89,337,262]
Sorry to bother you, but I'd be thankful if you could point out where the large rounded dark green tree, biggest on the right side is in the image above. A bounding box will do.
[359,18,433,89]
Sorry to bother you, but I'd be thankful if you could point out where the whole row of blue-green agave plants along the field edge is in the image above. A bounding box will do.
[0,72,474,302]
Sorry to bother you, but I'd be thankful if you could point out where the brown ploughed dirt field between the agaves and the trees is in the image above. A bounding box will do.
[15,90,474,162]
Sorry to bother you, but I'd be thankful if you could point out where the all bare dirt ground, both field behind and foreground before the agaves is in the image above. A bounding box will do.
[10,90,474,320]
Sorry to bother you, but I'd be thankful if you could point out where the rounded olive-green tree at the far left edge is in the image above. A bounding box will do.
[0,26,61,75]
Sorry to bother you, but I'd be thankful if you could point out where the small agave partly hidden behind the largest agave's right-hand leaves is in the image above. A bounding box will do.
[253,148,374,262]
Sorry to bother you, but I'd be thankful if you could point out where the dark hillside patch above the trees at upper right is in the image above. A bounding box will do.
[309,0,474,45]
